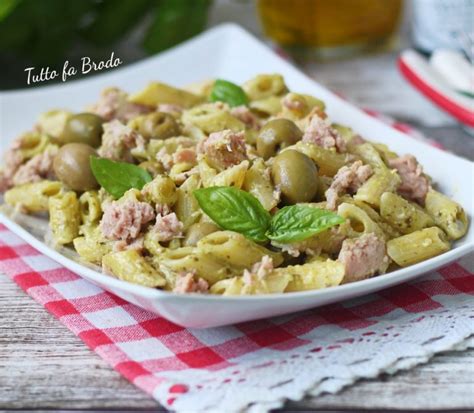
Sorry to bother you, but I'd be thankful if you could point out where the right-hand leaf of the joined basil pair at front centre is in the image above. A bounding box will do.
[266,205,344,243]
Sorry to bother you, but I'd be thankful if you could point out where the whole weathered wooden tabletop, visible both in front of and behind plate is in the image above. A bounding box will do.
[0,0,474,410]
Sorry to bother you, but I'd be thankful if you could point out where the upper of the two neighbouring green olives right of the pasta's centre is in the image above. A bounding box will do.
[257,119,303,159]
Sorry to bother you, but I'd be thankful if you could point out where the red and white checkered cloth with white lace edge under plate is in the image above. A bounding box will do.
[0,116,474,412]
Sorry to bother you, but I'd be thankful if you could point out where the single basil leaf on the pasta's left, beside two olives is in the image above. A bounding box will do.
[90,157,152,199]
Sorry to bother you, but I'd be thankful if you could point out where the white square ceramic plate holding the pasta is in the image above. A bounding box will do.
[0,24,474,327]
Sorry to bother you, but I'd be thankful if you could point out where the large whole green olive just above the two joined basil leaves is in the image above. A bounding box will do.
[272,149,319,204]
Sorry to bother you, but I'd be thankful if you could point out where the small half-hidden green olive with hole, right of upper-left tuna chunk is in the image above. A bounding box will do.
[129,112,181,139]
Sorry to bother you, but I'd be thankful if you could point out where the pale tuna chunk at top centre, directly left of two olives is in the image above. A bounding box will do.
[197,129,247,170]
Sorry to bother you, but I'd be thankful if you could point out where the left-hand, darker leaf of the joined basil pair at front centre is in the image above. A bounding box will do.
[193,186,271,242]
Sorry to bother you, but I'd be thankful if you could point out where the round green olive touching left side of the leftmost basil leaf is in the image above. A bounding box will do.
[53,143,99,191]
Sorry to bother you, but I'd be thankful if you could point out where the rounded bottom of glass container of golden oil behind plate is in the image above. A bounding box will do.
[258,0,403,58]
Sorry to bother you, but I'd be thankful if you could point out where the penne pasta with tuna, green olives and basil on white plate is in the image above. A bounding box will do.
[0,74,468,295]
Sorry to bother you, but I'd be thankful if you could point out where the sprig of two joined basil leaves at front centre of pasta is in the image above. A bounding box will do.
[194,187,344,243]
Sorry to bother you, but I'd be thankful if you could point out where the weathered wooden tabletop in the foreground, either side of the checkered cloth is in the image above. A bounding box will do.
[0,276,474,410]
